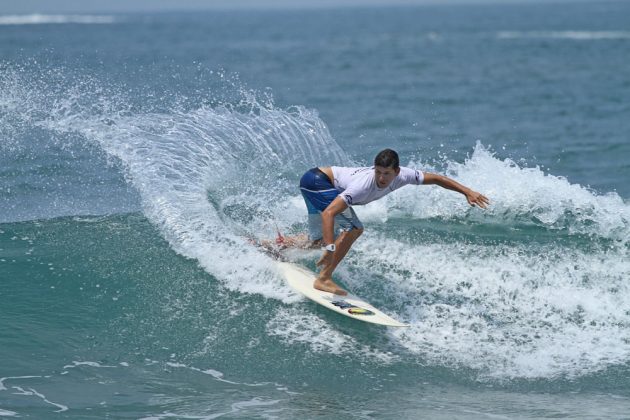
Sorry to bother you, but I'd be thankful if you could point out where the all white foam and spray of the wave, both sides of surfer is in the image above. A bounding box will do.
[6,67,630,378]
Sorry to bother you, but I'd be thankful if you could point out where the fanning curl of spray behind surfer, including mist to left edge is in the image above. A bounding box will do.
[2,65,348,298]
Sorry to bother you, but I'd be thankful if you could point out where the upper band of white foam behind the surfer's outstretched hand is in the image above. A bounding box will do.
[389,143,630,242]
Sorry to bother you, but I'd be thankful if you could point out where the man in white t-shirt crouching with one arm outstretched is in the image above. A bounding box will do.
[300,149,490,295]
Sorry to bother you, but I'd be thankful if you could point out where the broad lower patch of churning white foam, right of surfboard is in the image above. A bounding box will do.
[345,232,630,378]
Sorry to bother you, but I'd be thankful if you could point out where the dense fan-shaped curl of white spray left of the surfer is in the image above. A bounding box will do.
[42,96,344,300]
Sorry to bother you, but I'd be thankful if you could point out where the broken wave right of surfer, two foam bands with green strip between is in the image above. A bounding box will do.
[346,145,630,379]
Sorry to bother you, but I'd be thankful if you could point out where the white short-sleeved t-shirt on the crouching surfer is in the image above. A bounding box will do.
[331,166,424,206]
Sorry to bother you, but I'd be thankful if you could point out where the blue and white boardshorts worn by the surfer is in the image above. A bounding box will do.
[300,168,363,241]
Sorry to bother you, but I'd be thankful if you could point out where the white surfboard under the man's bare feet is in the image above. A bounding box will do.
[278,262,409,327]
